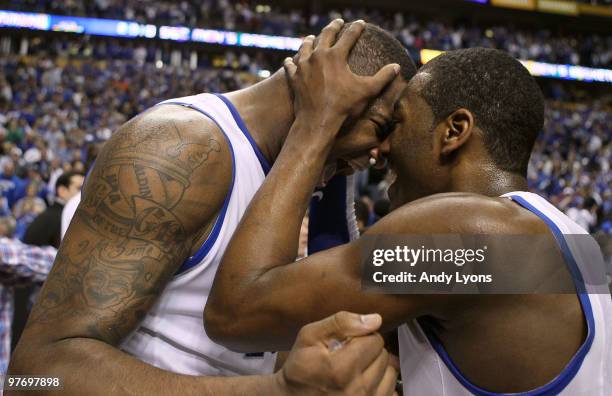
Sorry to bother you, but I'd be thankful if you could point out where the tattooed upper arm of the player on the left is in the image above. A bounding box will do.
[28,106,231,344]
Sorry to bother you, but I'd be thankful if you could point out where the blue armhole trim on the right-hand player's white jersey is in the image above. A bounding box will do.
[419,195,595,396]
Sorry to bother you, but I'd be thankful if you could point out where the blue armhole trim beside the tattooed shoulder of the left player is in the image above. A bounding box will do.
[162,102,236,276]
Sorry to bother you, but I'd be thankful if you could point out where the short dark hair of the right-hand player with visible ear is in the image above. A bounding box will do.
[419,48,544,175]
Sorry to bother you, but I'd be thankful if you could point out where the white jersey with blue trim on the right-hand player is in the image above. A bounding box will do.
[398,192,612,396]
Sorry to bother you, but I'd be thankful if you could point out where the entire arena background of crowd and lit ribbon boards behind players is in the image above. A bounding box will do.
[0,0,612,374]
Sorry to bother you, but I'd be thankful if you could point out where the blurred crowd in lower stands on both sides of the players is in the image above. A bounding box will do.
[0,45,612,240]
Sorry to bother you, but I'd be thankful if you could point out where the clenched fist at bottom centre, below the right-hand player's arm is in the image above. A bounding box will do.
[276,312,397,396]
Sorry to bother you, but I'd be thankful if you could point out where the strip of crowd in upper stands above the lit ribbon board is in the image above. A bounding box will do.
[3,0,612,68]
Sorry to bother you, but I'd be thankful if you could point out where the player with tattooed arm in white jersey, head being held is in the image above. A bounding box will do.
[10,20,416,395]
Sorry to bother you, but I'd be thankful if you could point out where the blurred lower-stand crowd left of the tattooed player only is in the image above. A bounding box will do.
[0,50,254,238]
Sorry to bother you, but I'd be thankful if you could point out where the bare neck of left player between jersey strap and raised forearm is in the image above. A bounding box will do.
[227,69,294,164]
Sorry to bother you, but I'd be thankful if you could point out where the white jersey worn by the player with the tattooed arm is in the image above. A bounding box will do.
[121,94,276,376]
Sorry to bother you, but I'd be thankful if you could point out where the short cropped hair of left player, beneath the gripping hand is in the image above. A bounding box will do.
[338,23,416,81]
